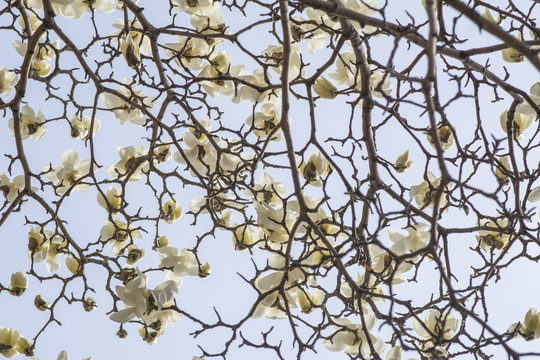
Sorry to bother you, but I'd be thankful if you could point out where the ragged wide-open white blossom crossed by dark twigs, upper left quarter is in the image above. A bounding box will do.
[101,78,155,126]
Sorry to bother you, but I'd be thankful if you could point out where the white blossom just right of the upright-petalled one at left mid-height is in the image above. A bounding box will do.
[107,145,149,181]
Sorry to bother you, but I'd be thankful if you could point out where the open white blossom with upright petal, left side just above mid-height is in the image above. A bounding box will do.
[43,150,90,194]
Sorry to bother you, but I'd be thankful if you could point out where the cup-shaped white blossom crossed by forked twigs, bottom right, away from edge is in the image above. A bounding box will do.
[412,309,459,341]
